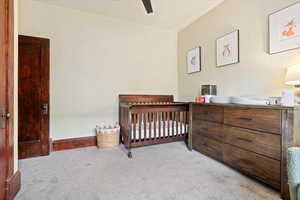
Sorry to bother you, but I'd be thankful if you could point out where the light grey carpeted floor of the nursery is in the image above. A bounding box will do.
[16,143,280,200]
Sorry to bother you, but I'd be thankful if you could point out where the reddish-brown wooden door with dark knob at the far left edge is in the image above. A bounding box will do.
[0,0,14,200]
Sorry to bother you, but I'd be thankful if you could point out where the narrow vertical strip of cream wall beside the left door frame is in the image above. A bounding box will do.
[14,0,19,172]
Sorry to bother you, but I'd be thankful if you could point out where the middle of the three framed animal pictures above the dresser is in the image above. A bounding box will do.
[216,30,240,67]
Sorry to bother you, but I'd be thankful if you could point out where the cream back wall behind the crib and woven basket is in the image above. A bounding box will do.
[19,0,177,139]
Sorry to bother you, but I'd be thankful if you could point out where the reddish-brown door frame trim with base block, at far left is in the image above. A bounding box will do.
[4,0,21,200]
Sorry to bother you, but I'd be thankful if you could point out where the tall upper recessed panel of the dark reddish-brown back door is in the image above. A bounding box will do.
[19,44,41,142]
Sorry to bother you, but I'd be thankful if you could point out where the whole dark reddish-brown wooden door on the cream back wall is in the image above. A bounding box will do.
[18,36,49,159]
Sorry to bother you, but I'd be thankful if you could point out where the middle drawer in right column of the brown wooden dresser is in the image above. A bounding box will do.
[223,125,281,160]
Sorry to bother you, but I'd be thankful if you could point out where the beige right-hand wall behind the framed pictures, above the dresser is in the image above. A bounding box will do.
[178,0,300,99]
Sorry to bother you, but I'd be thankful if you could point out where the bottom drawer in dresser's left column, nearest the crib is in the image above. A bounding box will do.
[193,135,223,161]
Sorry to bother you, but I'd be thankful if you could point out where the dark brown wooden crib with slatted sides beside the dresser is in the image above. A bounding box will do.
[119,95,189,158]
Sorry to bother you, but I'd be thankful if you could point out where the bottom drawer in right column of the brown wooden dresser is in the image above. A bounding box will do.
[223,144,280,189]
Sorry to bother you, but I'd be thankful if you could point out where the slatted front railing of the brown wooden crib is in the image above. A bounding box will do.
[120,104,189,148]
